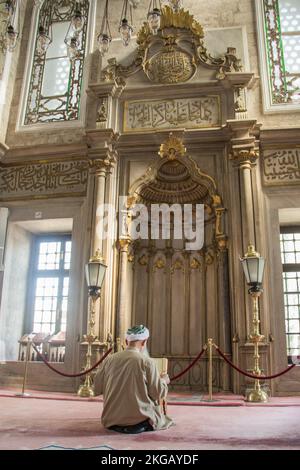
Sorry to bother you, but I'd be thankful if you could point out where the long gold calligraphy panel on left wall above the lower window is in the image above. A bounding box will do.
[0,161,88,200]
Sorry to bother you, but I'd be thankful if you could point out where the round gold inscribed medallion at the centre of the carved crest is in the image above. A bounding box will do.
[143,36,197,84]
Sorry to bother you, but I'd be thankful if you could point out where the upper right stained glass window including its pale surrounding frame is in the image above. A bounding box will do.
[256,0,300,111]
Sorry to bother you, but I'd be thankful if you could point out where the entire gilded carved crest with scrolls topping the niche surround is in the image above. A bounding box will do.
[102,6,242,85]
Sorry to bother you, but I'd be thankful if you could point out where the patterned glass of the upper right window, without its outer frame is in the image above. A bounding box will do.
[263,0,300,104]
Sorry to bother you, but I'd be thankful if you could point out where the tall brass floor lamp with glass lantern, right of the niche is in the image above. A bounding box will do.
[241,245,268,403]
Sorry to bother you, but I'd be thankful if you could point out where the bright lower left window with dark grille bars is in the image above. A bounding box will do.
[32,236,72,334]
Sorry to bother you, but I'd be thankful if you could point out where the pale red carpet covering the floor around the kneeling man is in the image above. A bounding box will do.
[0,391,300,450]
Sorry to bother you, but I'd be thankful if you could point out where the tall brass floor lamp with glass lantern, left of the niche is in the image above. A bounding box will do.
[78,250,107,397]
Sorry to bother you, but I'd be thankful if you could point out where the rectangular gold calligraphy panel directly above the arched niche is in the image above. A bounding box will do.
[124,96,221,132]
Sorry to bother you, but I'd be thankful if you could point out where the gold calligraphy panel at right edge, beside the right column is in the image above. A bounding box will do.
[263,148,300,186]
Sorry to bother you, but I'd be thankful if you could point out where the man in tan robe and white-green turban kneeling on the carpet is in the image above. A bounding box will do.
[95,325,173,434]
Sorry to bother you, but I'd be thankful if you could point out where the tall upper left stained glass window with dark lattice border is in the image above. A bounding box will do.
[24,0,89,125]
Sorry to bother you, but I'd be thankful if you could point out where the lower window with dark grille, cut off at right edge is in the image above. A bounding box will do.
[280,227,300,362]
